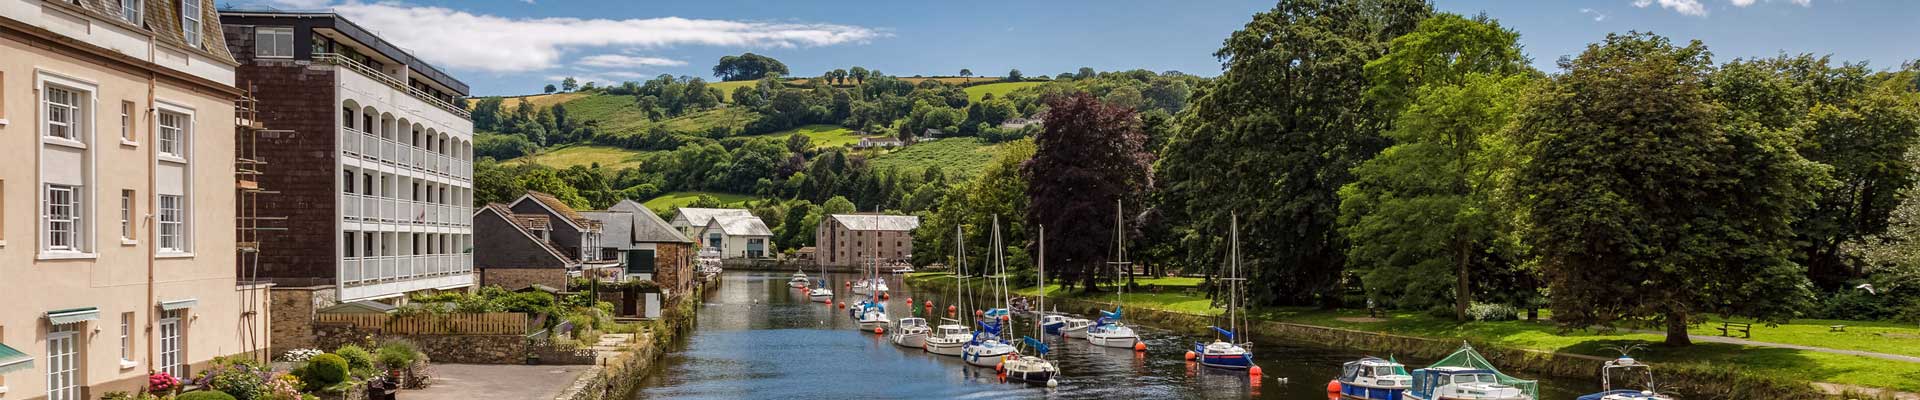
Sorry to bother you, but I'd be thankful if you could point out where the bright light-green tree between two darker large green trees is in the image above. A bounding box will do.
[1340,13,1528,321]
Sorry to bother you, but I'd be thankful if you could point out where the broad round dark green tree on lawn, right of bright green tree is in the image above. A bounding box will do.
[1513,33,1820,346]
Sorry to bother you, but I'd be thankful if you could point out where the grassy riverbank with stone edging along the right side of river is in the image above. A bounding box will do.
[906,275,1920,398]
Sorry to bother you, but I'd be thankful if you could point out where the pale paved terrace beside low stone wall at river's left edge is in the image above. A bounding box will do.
[399,363,593,400]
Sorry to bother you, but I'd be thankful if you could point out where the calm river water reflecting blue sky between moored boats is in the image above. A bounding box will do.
[637,271,1597,400]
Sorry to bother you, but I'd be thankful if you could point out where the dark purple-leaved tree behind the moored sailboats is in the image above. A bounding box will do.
[1020,92,1152,290]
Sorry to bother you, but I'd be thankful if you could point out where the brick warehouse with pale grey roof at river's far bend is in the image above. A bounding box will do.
[814,213,920,265]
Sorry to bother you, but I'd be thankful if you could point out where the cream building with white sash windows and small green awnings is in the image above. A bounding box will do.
[0,0,271,400]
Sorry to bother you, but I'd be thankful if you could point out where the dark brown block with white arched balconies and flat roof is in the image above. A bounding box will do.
[221,12,474,303]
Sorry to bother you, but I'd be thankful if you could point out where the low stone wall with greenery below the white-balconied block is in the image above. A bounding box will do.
[313,323,528,363]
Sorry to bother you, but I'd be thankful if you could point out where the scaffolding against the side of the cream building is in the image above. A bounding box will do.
[234,85,292,362]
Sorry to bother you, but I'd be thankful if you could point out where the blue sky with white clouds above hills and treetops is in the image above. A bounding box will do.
[219,0,1920,96]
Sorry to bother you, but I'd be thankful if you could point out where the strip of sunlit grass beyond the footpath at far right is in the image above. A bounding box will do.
[1690,317,1920,357]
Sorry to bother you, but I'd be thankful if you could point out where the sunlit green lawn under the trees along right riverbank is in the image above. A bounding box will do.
[908,273,1920,392]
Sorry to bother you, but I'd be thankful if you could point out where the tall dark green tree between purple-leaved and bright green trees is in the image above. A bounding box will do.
[1154,0,1432,306]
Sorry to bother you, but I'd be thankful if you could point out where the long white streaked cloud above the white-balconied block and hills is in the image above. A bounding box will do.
[326,0,887,73]
